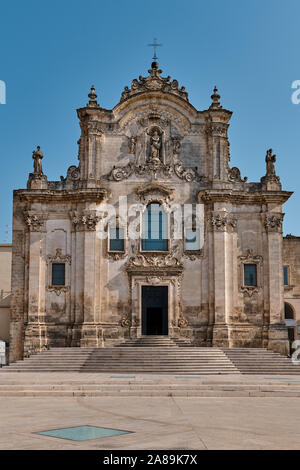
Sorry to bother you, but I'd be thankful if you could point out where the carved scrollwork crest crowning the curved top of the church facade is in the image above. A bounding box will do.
[120,62,189,103]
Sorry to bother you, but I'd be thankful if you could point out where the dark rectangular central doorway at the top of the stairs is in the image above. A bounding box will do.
[142,286,168,335]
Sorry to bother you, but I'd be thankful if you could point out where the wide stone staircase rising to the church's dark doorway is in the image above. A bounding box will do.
[2,344,300,375]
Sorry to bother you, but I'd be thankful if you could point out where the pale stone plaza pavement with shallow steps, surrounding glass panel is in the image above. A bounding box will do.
[0,370,300,450]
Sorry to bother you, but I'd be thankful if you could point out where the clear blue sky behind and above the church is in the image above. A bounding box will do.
[0,0,300,243]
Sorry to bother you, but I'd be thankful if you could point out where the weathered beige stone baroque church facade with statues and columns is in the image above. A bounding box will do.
[10,62,292,361]
